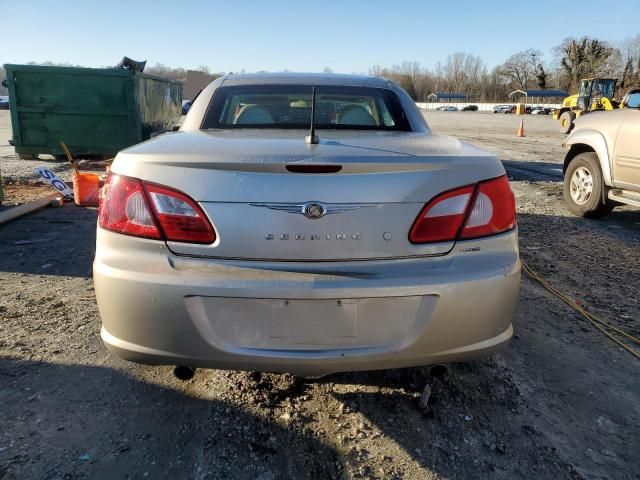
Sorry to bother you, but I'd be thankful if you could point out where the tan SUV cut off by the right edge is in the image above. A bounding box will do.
[563,89,640,218]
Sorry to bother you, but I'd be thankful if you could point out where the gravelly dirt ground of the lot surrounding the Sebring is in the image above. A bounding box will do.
[0,112,640,480]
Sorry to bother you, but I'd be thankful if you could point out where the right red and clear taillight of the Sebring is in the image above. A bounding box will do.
[409,175,516,243]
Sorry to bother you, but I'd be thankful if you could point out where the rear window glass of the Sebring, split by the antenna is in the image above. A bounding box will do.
[202,85,410,131]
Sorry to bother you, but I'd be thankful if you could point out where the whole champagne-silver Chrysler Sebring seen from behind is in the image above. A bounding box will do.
[94,74,520,376]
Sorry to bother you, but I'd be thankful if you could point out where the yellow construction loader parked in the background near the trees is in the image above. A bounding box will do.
[553,78,620,133]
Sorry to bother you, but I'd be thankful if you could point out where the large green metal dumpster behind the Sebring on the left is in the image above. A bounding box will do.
[4,65,182,158]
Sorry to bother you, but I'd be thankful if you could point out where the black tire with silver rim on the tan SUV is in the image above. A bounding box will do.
[562,152,614,218]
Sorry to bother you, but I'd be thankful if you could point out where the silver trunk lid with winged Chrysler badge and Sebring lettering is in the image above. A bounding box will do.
[113,130,504,261]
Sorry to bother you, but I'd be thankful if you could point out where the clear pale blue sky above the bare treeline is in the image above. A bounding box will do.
[5,0,640,73]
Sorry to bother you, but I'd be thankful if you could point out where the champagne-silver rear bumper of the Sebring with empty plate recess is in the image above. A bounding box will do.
[94,230,520,375]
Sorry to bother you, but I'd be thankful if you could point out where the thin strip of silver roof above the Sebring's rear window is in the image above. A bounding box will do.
[223,72,389,88]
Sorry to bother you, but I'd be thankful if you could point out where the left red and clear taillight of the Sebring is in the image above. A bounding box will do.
[98,174,216,243]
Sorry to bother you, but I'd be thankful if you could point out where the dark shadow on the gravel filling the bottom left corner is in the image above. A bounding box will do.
[0,358,340,480]
